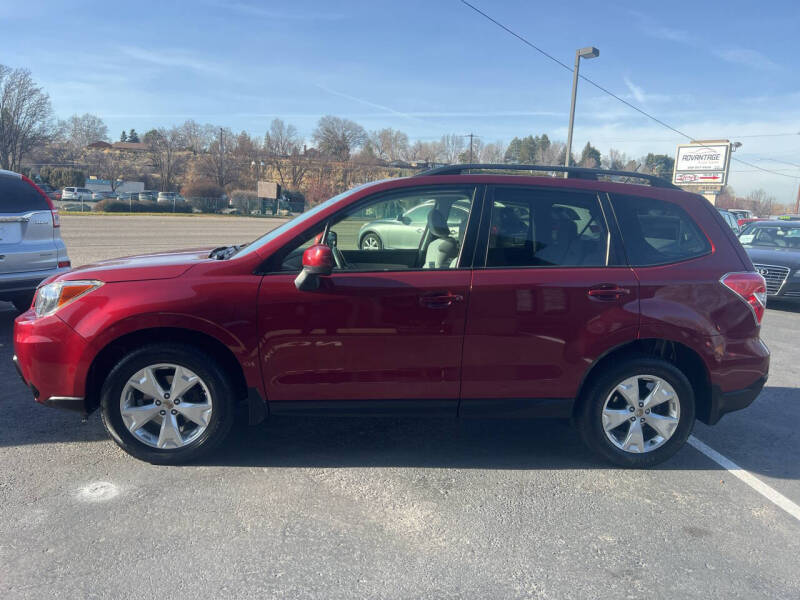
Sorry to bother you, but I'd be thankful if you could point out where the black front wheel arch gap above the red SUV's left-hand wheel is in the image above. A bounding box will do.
[84,327,248,413]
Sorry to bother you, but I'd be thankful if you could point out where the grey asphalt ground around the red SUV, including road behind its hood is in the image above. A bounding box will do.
[0,217,800,599]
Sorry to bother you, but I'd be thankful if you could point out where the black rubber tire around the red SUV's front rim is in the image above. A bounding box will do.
[100,343,236,465]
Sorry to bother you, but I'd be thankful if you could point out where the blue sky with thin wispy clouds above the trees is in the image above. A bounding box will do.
[0,0,800,202]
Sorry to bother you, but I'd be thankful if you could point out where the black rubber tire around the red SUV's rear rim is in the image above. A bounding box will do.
[575,356,695,468]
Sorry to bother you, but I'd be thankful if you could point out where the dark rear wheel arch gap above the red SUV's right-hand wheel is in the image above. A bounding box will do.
[573,338,711,422]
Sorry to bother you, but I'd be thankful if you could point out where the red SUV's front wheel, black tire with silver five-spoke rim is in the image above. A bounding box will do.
[100,344,234,464]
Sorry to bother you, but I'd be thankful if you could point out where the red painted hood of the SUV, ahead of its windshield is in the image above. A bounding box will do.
[59,248,213,283]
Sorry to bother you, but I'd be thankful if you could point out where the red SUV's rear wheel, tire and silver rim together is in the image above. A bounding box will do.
[576,357,695,468]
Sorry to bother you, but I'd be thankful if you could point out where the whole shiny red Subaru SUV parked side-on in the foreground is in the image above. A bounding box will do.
[14,165,769,467]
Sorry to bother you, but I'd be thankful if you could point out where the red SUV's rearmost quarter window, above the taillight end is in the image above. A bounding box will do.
[611,196,711,267]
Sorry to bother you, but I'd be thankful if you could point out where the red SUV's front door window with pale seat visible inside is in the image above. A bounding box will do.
[271,186,475,271]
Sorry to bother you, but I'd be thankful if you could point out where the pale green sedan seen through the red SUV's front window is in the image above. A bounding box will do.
[358,200,470,250]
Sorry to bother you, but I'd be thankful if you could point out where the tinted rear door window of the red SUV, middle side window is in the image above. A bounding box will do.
[486,187,608,267]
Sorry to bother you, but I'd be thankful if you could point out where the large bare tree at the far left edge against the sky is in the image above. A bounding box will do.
[0,65,53,171]
